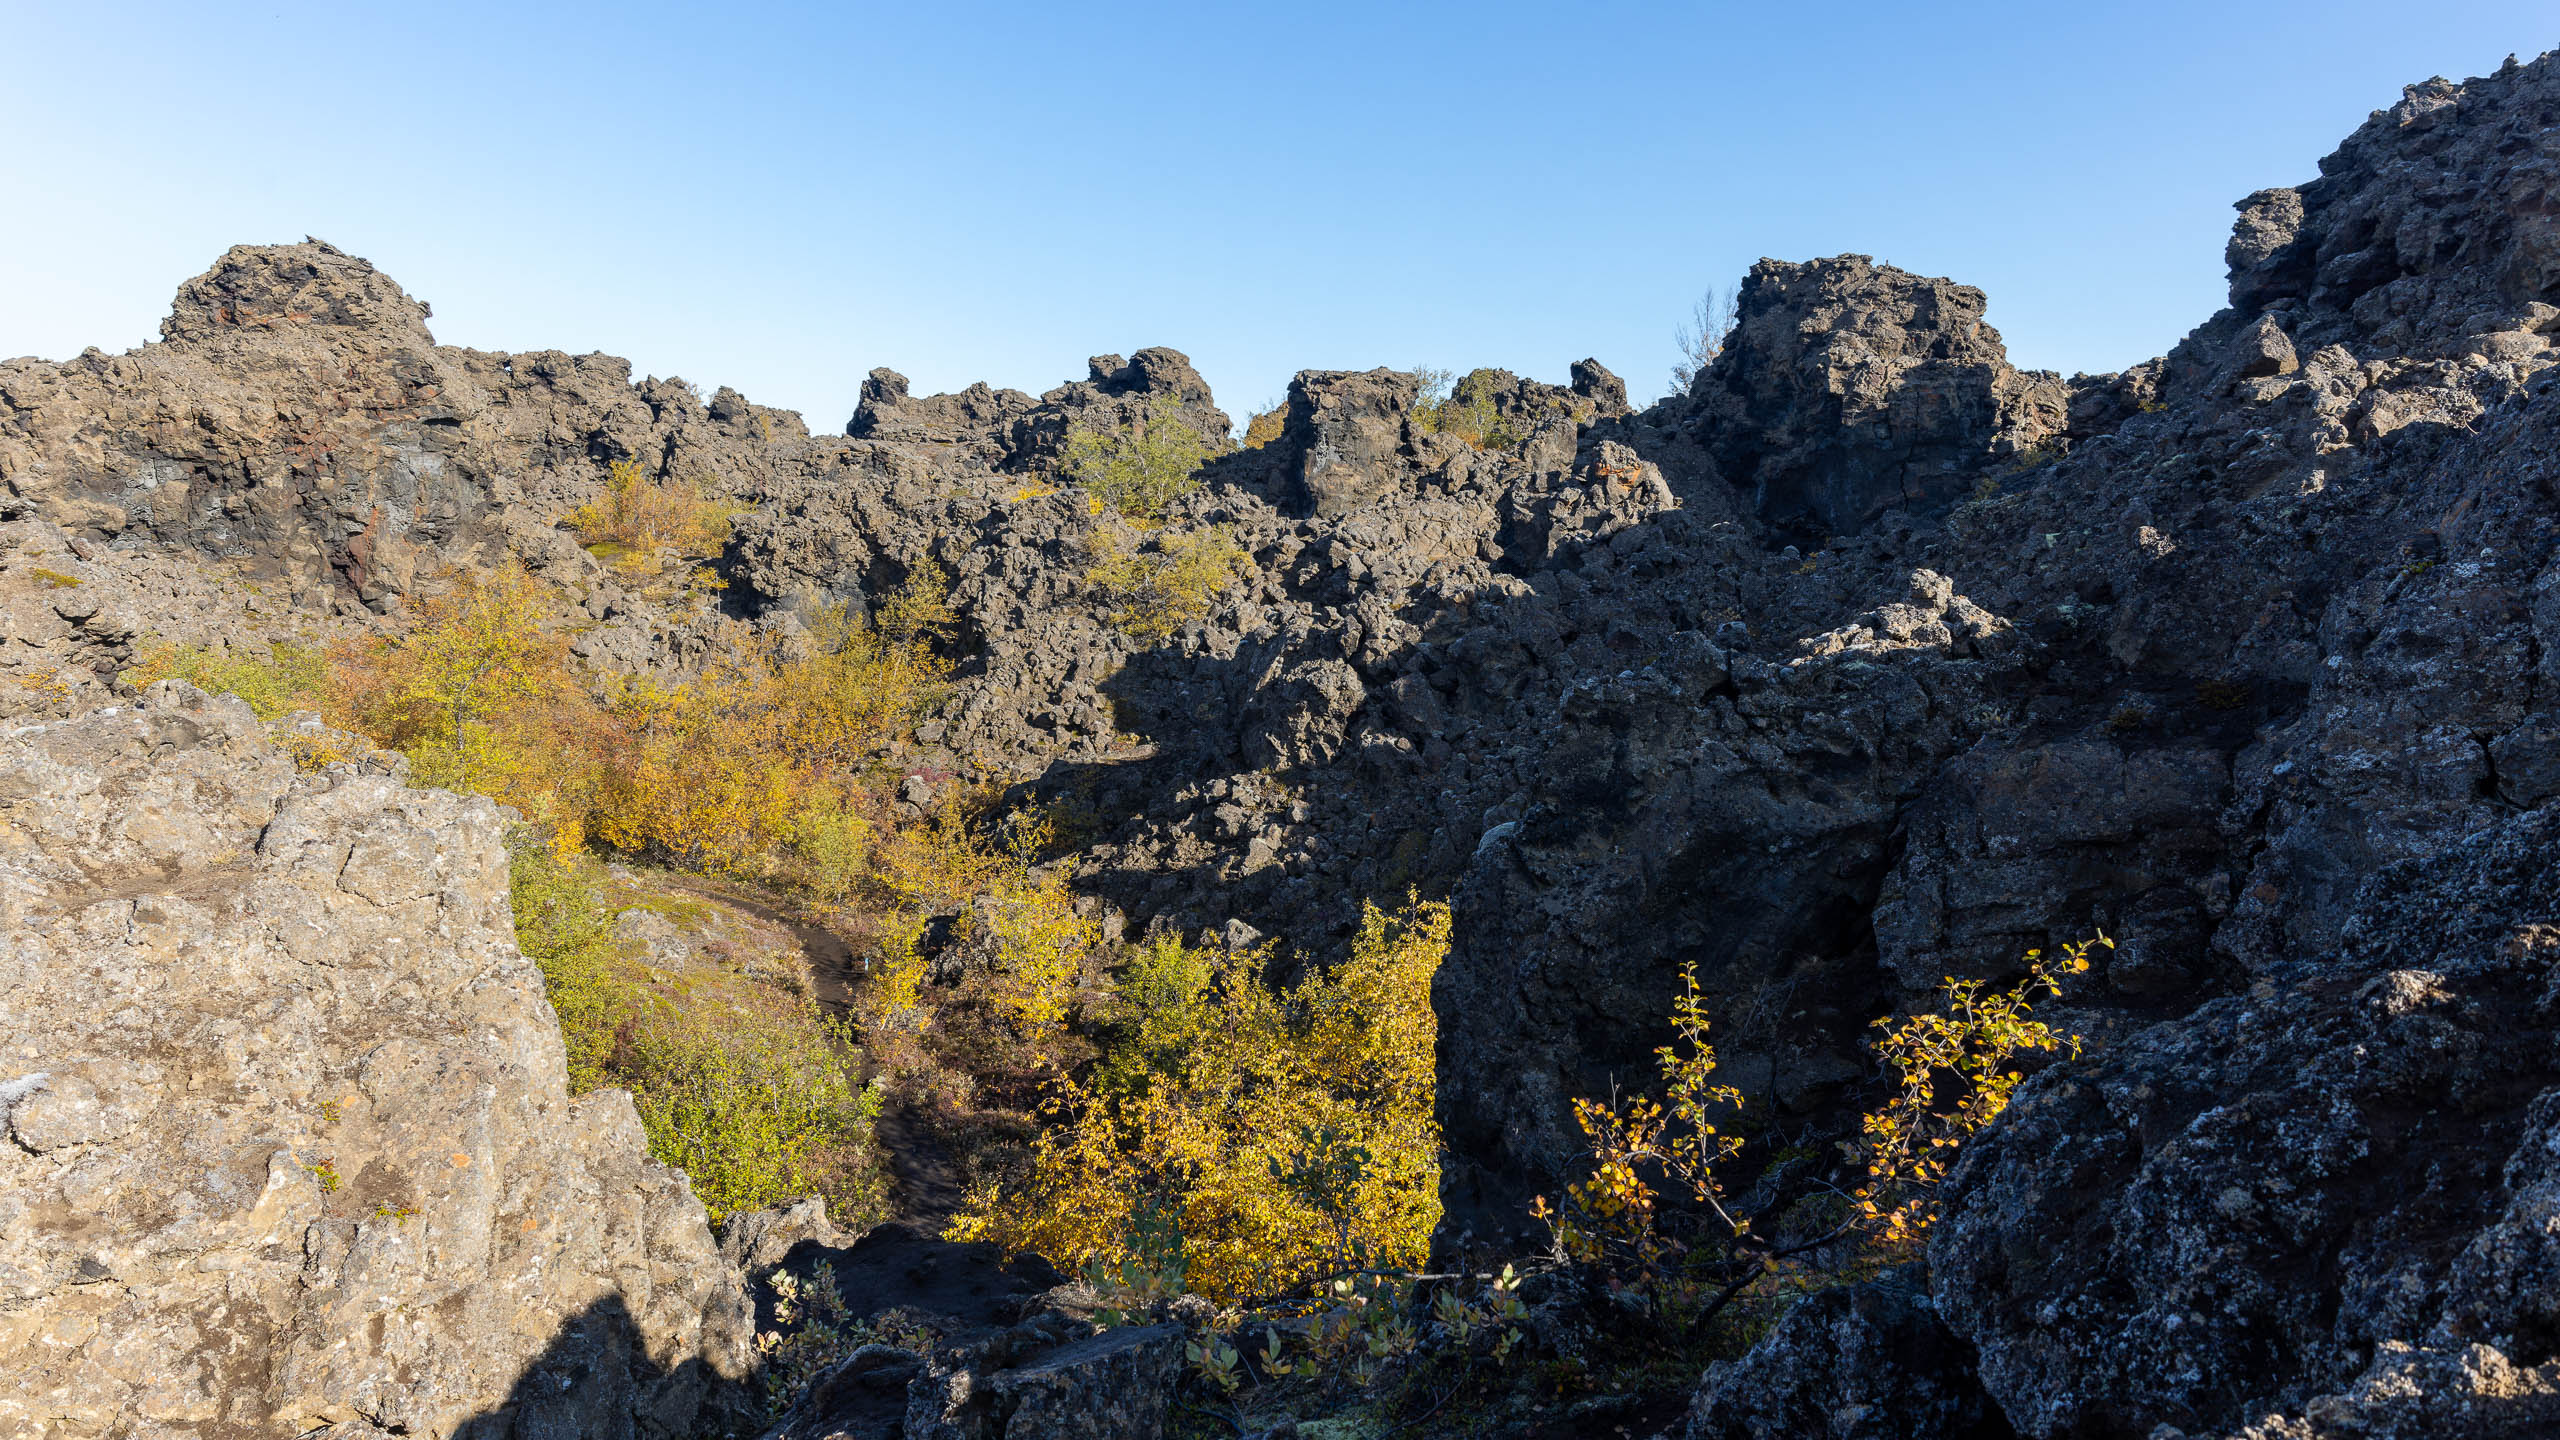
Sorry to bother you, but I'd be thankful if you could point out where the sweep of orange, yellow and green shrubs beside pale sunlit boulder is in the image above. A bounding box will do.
[128,556,1049,1222]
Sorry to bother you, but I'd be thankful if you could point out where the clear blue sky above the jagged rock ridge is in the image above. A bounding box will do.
[0,0,2560,430]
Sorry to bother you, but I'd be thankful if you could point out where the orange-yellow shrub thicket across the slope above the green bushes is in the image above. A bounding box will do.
[330,566,952,899]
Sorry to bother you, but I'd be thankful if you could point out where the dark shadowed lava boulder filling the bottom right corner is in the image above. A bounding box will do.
[1930,807,2560,1437]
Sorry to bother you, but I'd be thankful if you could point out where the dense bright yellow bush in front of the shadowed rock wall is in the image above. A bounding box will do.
[950,899,1449,1302]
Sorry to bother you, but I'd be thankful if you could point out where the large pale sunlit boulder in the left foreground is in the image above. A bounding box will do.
[0,676,753,1437]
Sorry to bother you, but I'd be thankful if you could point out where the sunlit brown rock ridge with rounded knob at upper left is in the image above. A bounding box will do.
[0,241,806,615]
